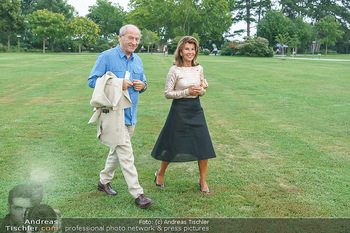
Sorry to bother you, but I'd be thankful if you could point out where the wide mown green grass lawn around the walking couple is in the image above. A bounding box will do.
[0,53,350,218]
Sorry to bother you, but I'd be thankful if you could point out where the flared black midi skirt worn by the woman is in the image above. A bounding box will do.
[151,97,216,162]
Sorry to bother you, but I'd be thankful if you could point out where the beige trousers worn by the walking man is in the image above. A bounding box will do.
[100,125,143,199]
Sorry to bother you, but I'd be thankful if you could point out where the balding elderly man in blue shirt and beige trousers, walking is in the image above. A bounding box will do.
[88,24,154,209]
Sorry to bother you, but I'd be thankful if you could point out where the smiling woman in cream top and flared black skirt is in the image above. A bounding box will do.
[152,36,216,193]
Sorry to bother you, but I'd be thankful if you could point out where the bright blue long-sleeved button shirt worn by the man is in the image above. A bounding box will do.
[88,45,147,125]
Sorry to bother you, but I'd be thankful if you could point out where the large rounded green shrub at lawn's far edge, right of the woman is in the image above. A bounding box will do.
[236,37,273,57]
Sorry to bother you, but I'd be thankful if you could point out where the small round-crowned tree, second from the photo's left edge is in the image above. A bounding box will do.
[27,9,66,53]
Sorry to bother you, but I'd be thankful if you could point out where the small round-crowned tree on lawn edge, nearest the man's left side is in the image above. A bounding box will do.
[69,17,100,53]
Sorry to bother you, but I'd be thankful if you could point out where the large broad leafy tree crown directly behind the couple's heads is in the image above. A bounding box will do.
[127,0,233,42]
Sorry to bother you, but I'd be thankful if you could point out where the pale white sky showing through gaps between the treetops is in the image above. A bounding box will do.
[67,0,252,40]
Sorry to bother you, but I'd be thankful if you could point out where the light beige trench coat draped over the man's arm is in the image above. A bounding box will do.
[89,71,132,148]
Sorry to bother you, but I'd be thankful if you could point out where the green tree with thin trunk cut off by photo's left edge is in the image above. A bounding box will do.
[0,0,24,51]
